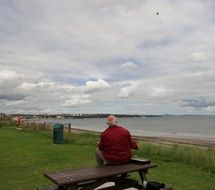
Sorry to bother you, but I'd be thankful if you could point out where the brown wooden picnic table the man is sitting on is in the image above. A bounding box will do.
[39,159,157,190]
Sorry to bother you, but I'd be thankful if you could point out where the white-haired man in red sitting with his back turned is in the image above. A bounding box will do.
[96,115,139,166]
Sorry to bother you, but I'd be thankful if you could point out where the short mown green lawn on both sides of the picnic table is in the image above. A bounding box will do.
[0,127,215,190]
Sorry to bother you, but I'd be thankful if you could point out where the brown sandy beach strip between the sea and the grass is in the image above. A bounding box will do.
[68,128,215,147]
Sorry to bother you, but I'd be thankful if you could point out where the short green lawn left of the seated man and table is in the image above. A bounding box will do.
[0,128,95,190]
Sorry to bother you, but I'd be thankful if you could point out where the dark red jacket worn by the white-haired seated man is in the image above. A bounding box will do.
[98,125,138,164]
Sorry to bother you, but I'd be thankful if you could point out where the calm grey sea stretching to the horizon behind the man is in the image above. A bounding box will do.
[31,115,215,140]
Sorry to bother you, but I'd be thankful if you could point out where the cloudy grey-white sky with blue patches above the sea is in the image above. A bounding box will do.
[0,0,215,115]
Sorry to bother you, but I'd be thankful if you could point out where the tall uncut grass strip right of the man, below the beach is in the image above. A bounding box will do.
[137,143,215,174]
